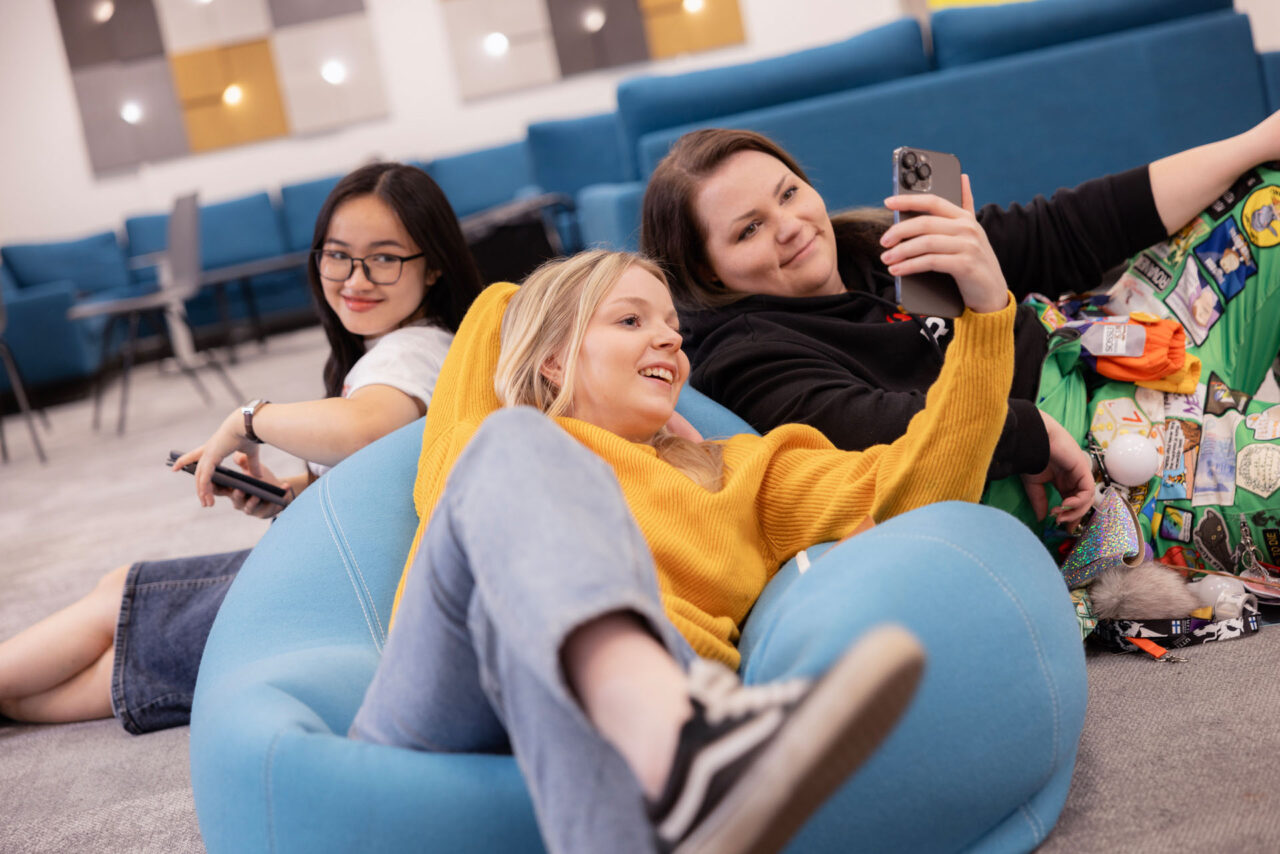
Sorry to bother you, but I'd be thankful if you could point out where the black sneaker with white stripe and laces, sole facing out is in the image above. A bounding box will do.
[645,626,924,854]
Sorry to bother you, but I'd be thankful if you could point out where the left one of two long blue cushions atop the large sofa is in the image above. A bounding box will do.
[618,18,929,178]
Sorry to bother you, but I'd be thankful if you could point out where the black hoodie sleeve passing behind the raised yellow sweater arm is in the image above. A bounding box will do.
[690,337,1048,479]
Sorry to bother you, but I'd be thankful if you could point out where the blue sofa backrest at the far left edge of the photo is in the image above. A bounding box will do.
[0,232,131,292]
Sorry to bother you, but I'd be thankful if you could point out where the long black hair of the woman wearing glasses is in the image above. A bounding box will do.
[307,163,484,397]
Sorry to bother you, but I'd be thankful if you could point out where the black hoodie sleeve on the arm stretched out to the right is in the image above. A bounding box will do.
[978,166,1167,300]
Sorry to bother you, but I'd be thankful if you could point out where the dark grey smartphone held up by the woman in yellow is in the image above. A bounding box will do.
[893,146,964,318]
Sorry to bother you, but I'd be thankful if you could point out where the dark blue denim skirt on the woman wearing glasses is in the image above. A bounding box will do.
[111,549,250,735]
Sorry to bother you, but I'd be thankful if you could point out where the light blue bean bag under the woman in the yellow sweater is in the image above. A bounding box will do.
[191,389,1085,854]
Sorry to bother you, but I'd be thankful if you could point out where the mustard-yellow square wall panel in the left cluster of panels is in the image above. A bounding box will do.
[172,40,289,151]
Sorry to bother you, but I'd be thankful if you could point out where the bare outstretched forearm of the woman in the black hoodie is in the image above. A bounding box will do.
[1151,111,1280,234]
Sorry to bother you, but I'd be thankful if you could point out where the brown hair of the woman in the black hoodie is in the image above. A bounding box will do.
[640,128,892,309]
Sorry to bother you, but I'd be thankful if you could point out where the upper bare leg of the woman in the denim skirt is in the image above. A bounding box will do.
[0,566,129,702]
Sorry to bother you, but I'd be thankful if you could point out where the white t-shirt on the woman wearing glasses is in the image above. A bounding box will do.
[307,323,453,478]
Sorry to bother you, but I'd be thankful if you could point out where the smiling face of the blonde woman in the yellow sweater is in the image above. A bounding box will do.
[543,265,689,442]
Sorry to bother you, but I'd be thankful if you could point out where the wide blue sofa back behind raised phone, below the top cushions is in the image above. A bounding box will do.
[645,13,1267,210]
